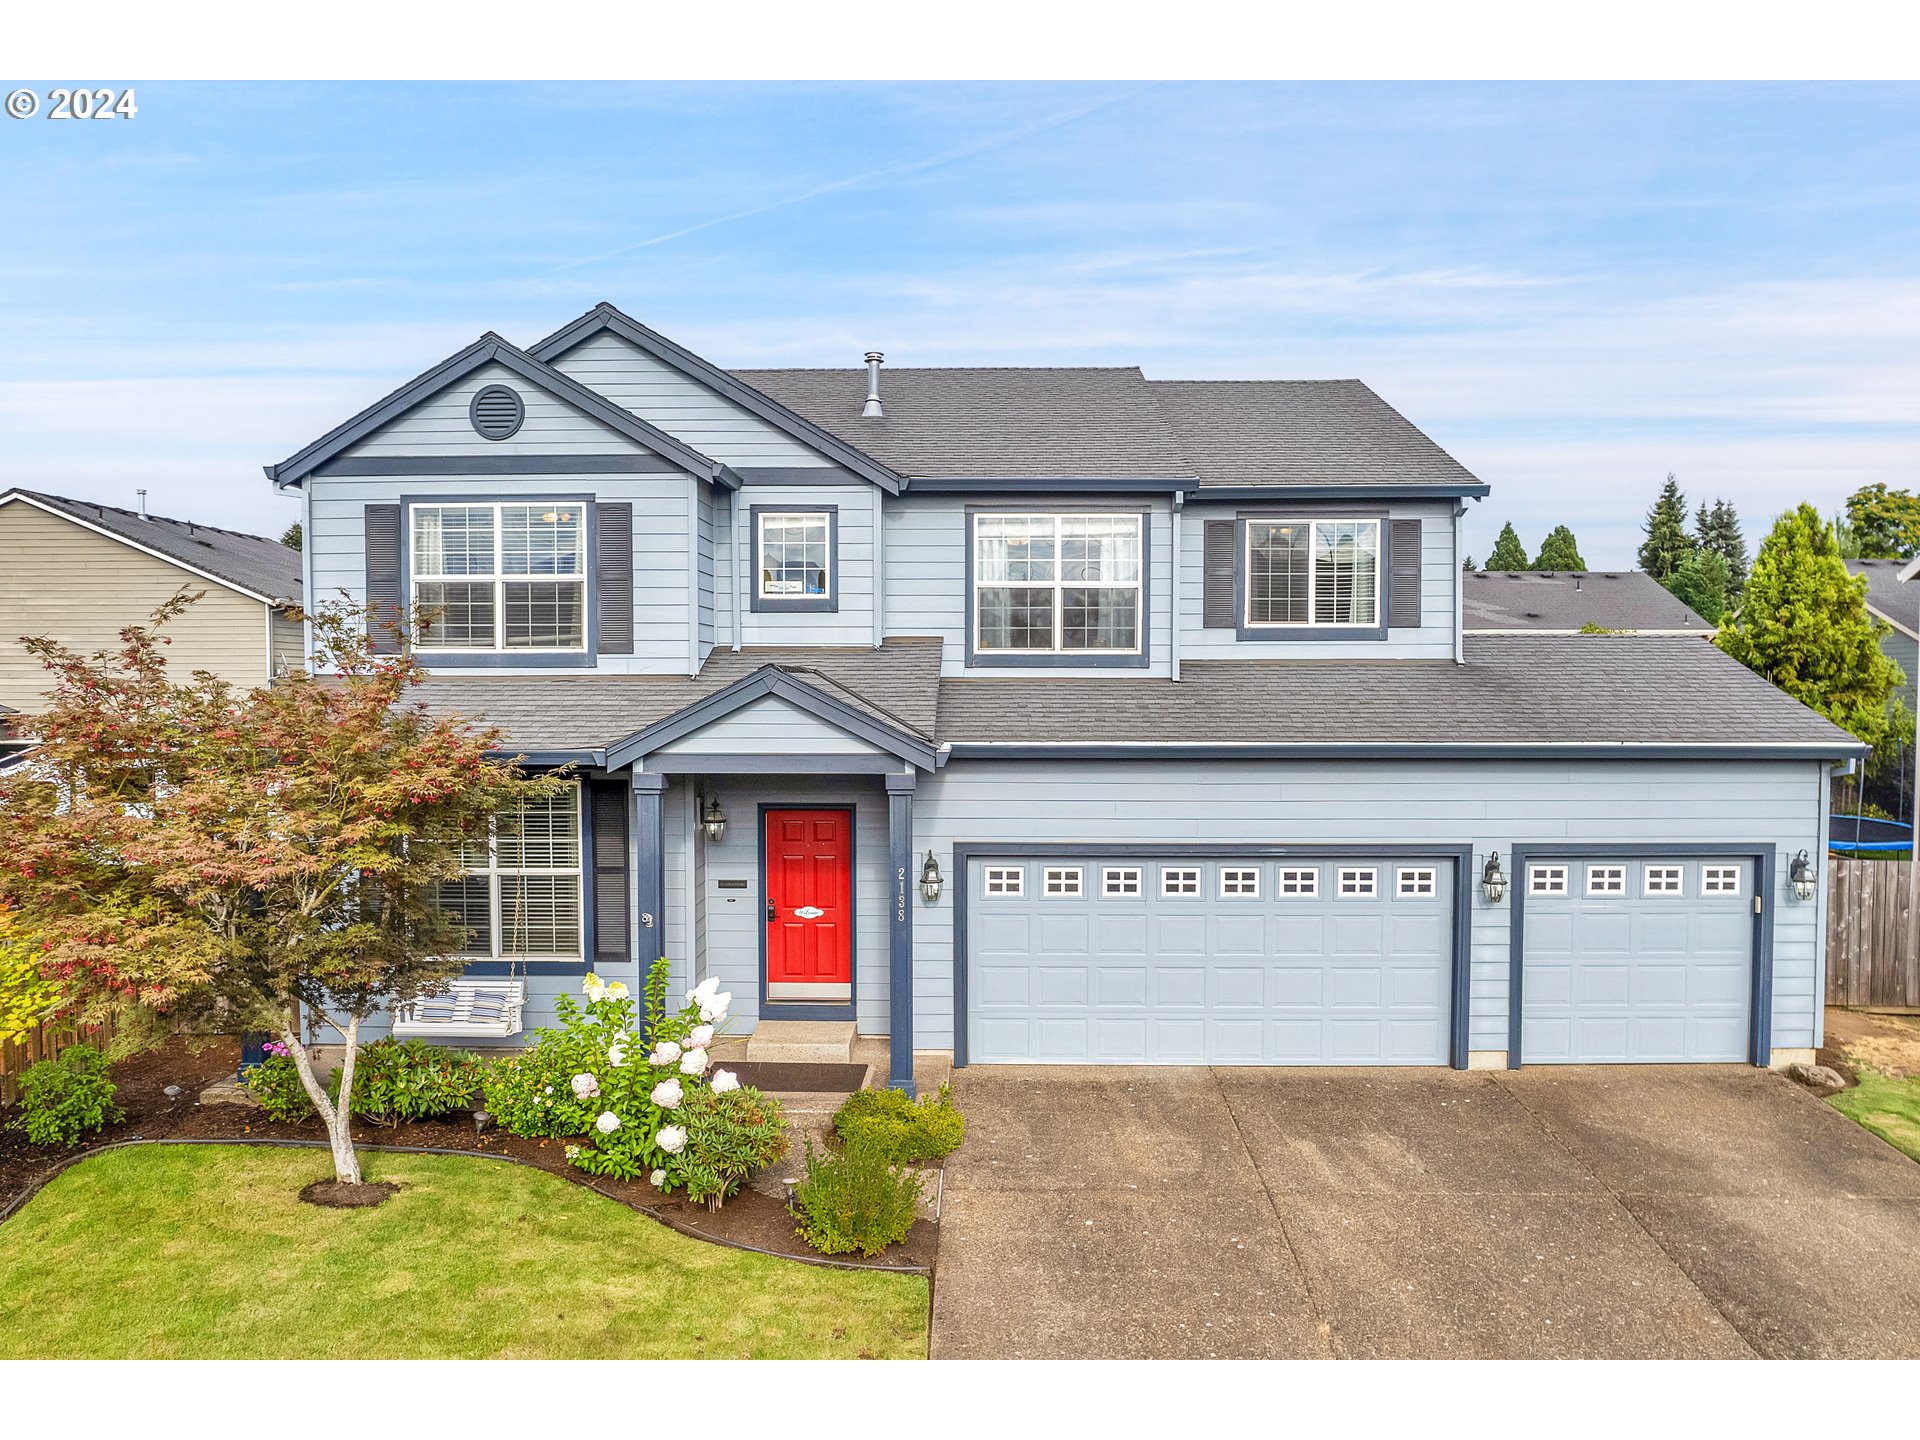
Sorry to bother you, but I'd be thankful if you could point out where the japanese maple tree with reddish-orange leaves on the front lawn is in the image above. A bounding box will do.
[0,595,566,1185]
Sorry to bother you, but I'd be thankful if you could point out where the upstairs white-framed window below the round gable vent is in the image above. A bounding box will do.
[420,501,588,651]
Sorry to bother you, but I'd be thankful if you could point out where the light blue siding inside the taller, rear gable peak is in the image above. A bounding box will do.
[553,334,831,467]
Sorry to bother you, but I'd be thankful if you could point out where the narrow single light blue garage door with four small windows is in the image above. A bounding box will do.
[1521,856,1753,1066]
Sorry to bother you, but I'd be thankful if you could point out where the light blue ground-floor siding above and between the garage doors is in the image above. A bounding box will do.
[914,760,1826,1050]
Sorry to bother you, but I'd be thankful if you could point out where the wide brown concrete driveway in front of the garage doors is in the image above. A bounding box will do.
[933,1066,1920,1357]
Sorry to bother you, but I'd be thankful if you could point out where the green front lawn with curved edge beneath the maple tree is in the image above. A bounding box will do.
[0,1146,927,1359]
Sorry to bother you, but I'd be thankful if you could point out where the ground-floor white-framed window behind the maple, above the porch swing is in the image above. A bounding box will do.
[440,783,586,960]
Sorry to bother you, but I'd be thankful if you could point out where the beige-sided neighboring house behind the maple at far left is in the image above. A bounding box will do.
[0,490,303,716]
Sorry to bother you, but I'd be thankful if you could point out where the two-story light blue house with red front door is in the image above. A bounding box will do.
[269,305,1860,1085]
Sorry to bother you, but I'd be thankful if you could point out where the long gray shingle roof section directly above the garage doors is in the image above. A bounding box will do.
[939,636,1857,751]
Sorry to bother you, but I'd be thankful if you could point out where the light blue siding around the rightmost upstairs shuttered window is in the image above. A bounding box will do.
[1179,501,1459,660]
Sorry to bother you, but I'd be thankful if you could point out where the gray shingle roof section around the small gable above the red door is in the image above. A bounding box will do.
[415,637,941,751]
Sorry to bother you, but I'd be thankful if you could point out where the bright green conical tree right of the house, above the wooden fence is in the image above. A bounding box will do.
[1716,505,1901,745]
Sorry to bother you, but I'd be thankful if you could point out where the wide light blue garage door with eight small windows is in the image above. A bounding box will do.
[968,856,1453,1066]
